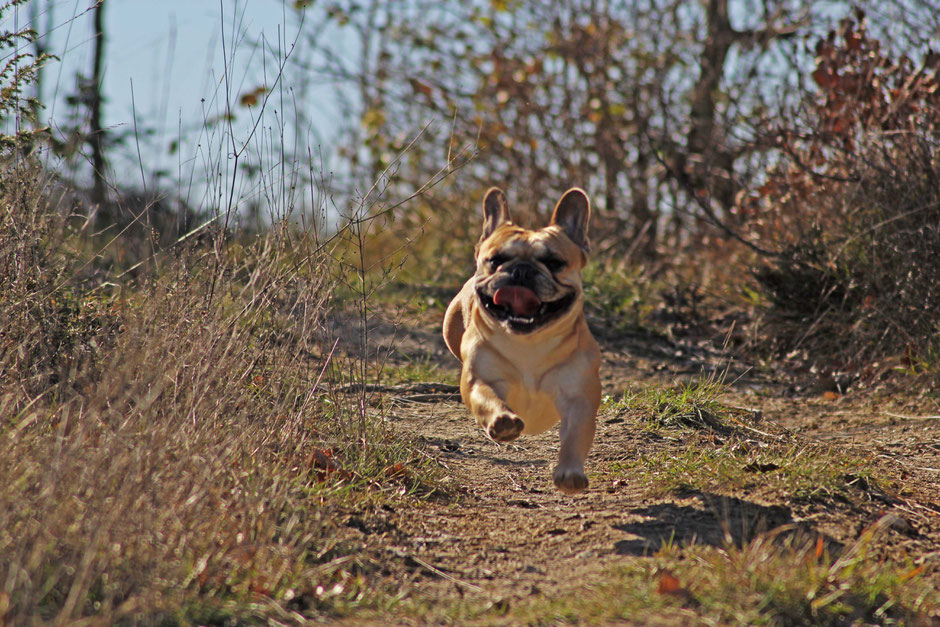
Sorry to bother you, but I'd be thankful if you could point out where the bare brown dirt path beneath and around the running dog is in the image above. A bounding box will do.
[350,314,940,624]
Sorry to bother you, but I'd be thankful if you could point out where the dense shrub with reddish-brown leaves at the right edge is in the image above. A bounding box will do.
[744,14,940,376]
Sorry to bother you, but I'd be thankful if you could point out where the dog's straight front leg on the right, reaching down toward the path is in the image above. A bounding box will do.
[552,397,598,494]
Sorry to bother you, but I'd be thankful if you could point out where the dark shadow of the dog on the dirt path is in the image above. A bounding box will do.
[614,491,842,556]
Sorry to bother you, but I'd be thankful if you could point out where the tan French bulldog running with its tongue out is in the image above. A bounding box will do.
[444,187,601,494]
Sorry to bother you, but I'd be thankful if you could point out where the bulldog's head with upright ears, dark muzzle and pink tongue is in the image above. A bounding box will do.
[474,188,590,334]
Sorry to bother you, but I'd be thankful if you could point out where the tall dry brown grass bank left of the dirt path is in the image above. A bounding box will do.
[0,161,446,623]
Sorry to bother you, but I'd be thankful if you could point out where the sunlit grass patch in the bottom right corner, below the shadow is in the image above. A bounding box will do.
[504,517,940,626]
